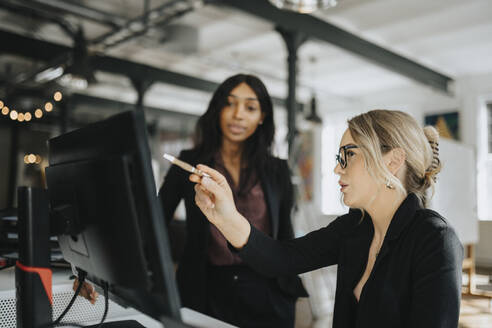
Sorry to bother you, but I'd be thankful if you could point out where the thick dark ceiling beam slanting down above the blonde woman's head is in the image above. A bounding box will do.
[223,0,452,93]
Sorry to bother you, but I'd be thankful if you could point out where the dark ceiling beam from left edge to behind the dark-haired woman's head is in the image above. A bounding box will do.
[0,30,292,106]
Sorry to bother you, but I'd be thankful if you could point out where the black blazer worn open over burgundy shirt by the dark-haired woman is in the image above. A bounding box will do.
[159,150,307,312]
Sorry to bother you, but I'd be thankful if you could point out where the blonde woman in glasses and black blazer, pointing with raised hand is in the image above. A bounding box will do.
[190,110,463,328]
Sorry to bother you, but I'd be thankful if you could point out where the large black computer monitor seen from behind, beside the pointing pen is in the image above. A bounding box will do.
[46,111,180,320]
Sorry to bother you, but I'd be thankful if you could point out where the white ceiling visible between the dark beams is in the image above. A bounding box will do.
[0,0,492,119]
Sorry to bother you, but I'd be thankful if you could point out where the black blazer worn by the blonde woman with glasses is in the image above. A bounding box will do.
[238,194,463,328]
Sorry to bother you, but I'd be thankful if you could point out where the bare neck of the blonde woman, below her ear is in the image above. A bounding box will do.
[365,187,405,241]
